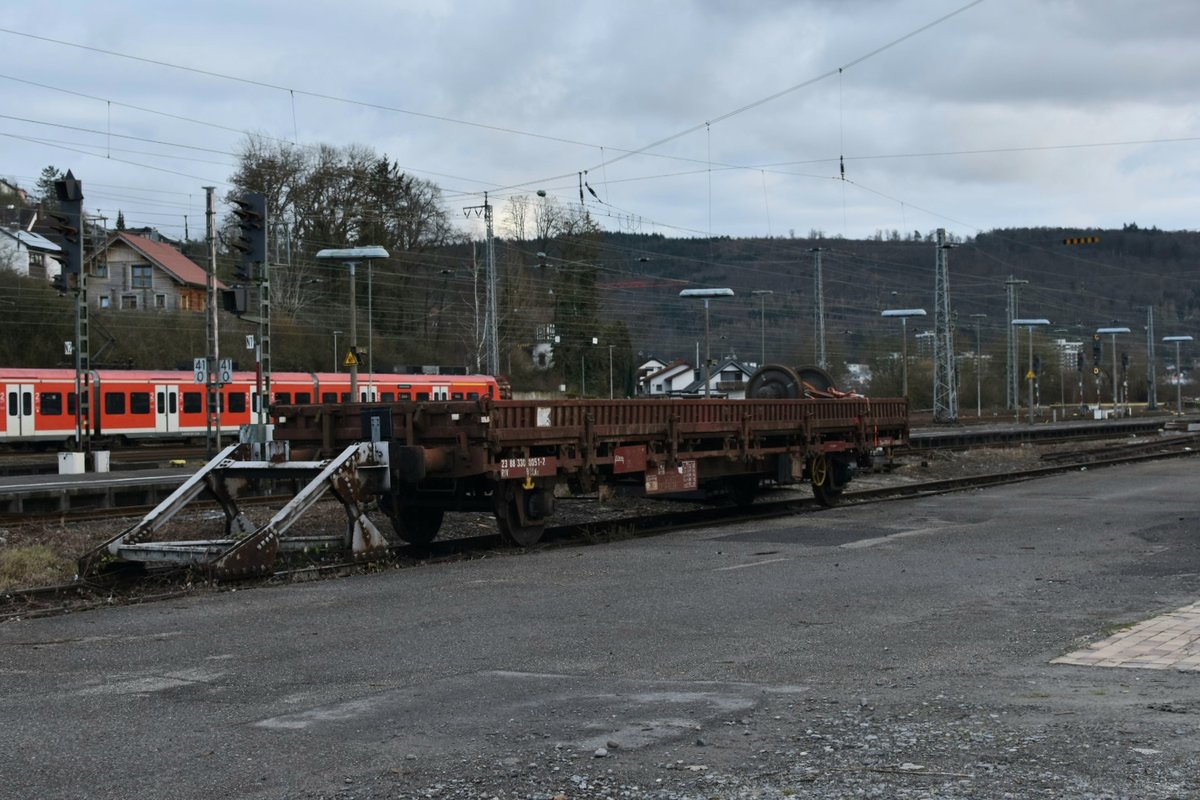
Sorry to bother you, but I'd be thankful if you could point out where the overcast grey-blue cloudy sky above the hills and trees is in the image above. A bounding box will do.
[0,0,1200,244]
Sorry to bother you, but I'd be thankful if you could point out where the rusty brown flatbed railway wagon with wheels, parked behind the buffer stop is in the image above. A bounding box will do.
[275,381,908,546]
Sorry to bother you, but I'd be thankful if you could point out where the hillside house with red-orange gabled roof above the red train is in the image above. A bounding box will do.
[88,230,224,312]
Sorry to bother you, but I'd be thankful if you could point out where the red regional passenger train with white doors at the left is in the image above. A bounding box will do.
[0,368,509,447]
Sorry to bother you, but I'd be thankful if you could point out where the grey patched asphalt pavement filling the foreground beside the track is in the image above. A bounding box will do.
[0,457,1200,800]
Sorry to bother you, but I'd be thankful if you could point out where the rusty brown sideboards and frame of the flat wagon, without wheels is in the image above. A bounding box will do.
[276,397,908,481]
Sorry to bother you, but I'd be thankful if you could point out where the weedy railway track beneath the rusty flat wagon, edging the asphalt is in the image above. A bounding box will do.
[0,435,1200,622]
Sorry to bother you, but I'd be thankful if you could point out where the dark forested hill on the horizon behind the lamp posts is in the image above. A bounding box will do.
[566,224,1200,359]
